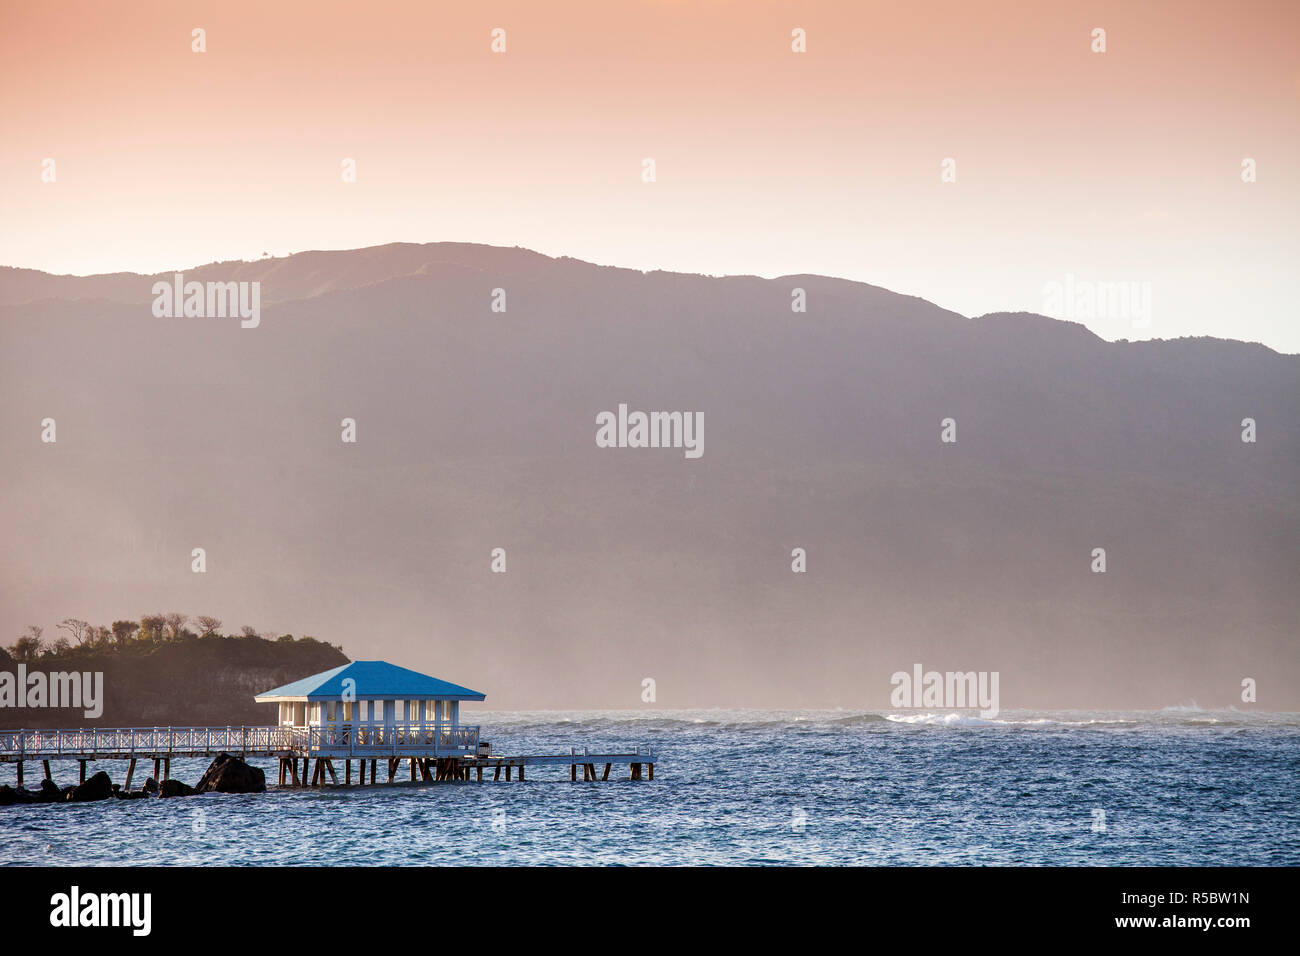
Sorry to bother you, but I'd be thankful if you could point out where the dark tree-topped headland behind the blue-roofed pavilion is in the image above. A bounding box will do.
[0,637,347,730]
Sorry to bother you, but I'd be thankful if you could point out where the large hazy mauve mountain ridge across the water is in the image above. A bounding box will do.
[0,243,1300,719]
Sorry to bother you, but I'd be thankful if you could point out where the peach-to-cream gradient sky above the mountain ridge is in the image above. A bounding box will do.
[0,0,1300,352]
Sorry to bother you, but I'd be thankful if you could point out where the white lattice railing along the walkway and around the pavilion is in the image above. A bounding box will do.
[0,723,478,761]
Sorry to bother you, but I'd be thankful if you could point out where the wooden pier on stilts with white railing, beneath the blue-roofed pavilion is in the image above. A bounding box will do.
[0,724,658,790]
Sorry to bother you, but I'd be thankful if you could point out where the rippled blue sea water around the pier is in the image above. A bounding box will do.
[0,710,1300,866]
